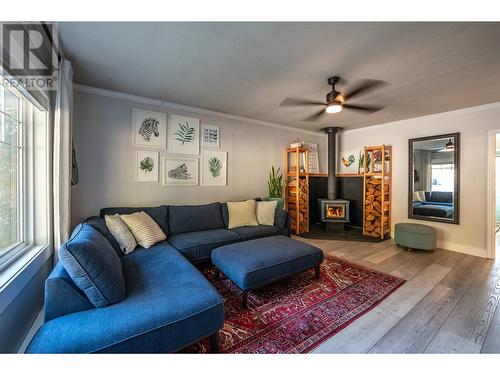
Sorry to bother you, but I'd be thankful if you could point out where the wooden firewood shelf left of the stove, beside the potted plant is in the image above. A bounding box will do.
[285,147,309,234]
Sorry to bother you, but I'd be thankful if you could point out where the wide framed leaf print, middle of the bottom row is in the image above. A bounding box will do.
[162,157,198,186]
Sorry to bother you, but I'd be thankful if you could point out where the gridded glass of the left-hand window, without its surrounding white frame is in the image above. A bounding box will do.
[0,85,25,262]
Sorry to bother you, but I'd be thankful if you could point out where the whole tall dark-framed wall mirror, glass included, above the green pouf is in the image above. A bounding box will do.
[408,133,460,224]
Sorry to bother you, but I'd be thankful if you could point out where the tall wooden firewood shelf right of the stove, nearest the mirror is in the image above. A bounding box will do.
[363,145,392,239]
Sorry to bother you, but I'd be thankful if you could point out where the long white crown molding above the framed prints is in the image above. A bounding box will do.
[73,84,326,138]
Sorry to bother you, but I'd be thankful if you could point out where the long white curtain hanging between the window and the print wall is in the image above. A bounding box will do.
[52,59,73,251]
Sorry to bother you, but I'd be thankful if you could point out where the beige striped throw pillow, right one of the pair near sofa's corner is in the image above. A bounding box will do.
[120,211,167,249]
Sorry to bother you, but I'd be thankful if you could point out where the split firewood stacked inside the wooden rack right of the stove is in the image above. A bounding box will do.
[364,178,390,237]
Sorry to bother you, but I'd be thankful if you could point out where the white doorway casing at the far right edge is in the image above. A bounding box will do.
[486,129,500,259]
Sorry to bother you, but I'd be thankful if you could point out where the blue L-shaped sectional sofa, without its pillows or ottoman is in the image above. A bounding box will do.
[27,202,290,353]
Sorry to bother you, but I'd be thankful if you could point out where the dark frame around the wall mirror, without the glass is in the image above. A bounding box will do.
[408,133,460,225]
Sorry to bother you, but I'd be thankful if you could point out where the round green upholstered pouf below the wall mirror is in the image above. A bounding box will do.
[394,223,436,250]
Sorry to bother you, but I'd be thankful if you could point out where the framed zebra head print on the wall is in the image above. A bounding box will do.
[132,108,167,149]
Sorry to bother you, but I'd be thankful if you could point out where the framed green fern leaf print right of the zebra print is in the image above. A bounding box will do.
[169,115,200,155]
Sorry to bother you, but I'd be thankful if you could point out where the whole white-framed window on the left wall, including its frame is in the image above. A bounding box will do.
[0,75,50,274]
